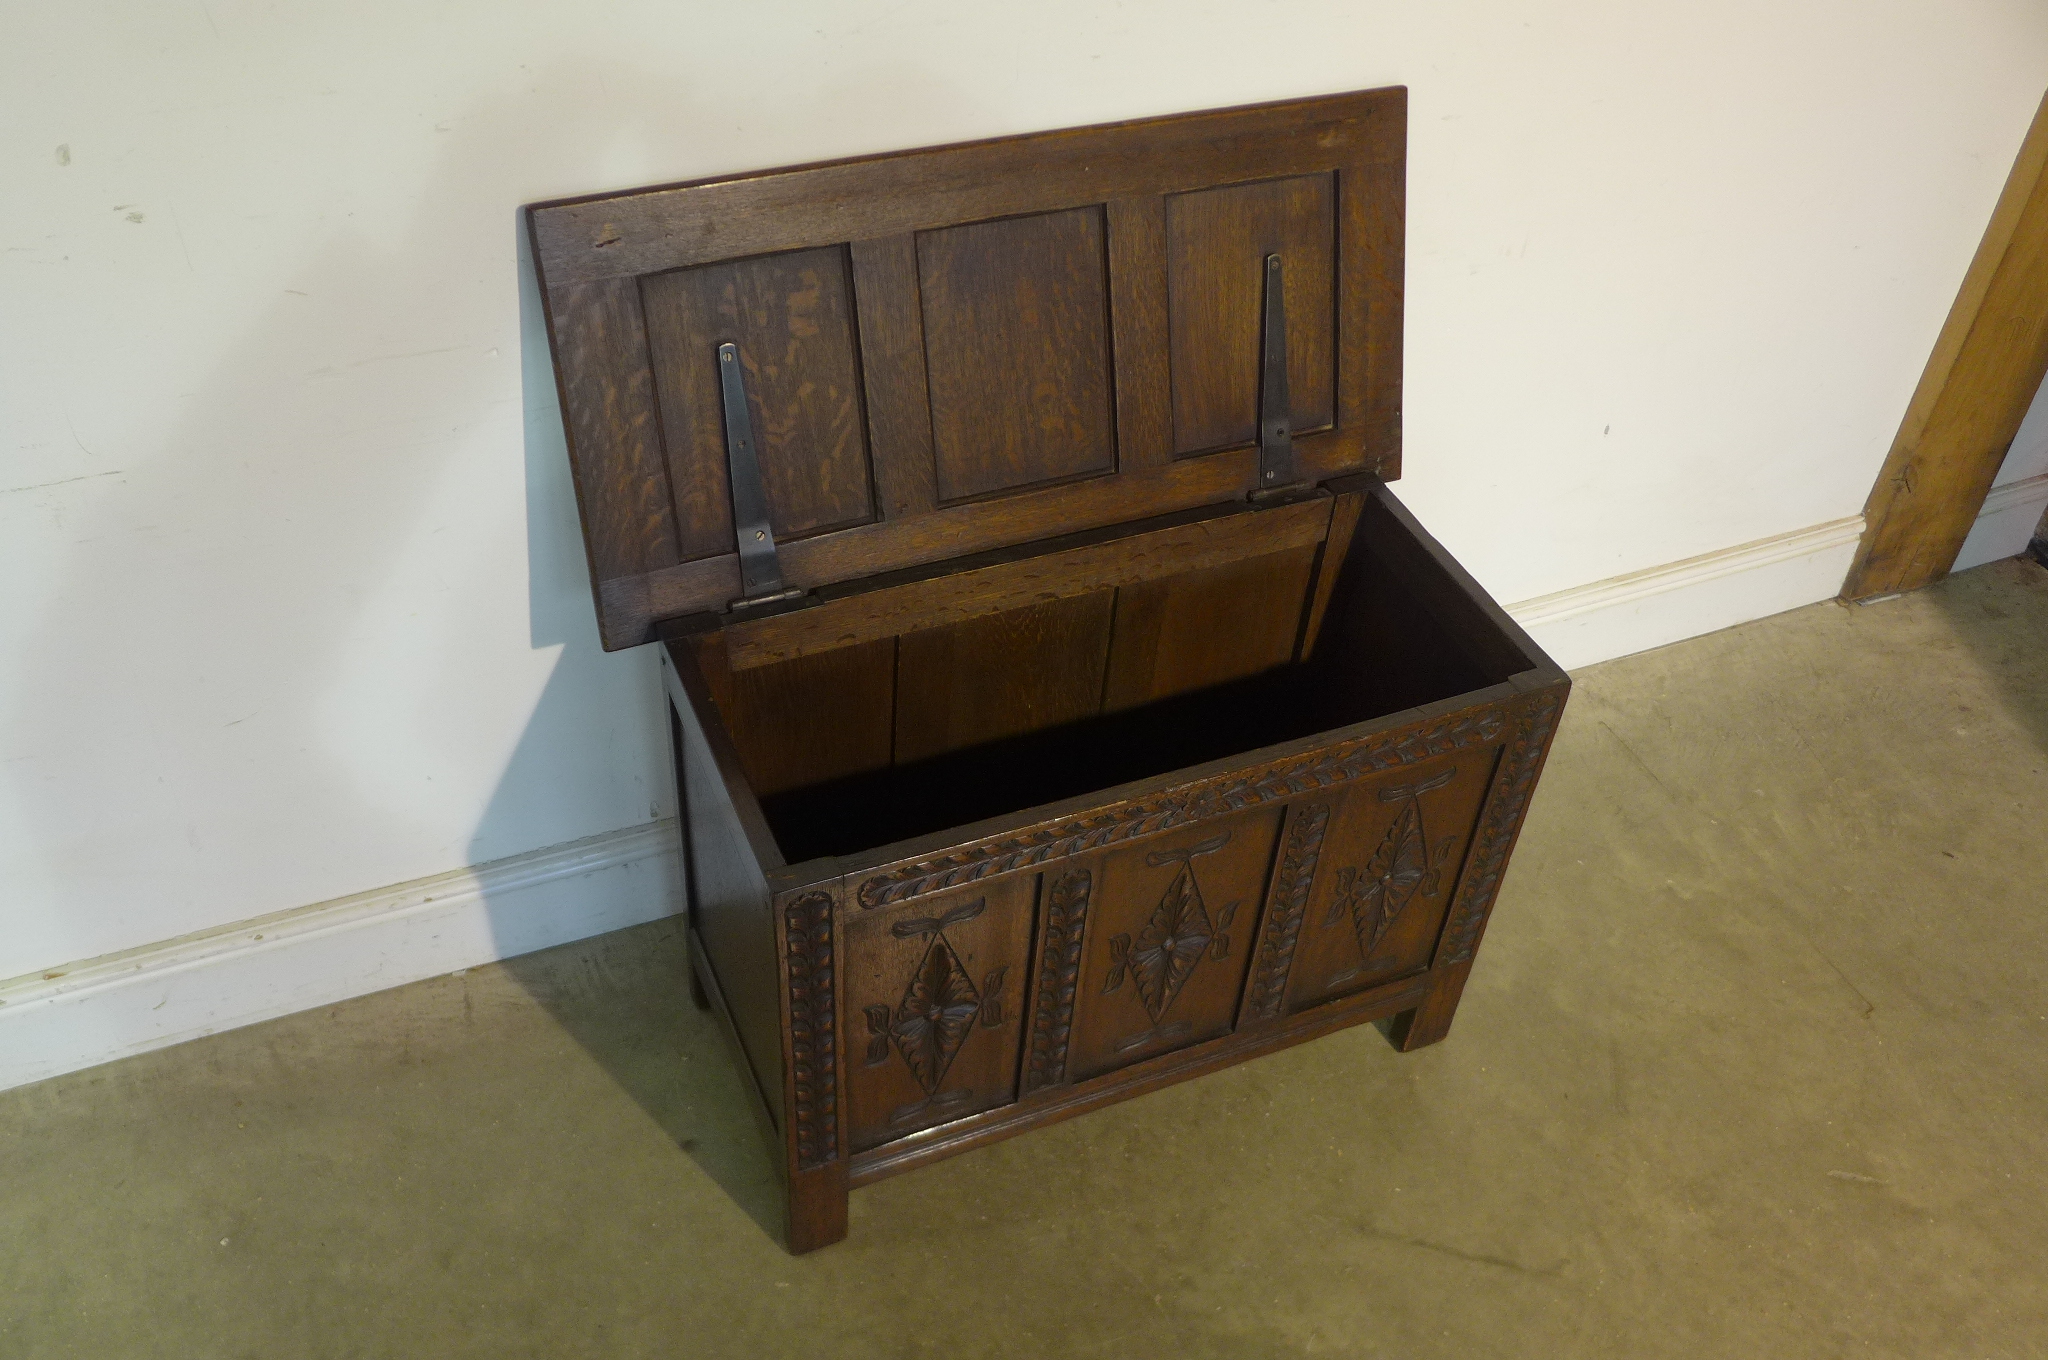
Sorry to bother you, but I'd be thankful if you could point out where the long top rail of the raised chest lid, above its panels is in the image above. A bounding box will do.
[530,88,1407,285]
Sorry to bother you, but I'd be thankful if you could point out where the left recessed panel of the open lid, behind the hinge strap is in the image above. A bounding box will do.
[641,250,874,559]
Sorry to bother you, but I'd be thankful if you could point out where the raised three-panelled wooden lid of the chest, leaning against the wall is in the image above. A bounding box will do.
[528,88,1407,649]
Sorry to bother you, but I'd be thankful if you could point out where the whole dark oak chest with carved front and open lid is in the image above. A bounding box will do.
[530,90,1569,1251]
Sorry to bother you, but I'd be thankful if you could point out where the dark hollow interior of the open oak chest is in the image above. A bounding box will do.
[670,494,1532,862]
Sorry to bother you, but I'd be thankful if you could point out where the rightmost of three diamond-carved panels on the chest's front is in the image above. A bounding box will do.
[1286,746,1499,1012]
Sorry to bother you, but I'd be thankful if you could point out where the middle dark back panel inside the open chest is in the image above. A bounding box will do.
[895,590,1116,764]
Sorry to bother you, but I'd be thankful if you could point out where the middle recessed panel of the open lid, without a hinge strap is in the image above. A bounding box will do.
[918,209,1116,502]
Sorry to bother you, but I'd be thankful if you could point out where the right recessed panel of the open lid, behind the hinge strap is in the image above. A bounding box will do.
[1165,174,1337,455]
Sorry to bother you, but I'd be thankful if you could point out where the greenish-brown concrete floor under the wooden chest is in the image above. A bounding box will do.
[0,561,2048,1360]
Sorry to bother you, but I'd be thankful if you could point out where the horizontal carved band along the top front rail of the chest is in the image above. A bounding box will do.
[860,709,1505,909]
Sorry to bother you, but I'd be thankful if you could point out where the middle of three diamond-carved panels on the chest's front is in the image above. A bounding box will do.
[1067,809,1280,1081]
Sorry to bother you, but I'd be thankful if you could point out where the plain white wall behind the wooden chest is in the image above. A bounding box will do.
[0,0,2048,1048]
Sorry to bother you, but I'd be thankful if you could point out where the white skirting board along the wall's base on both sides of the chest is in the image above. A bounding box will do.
[0,499,2048,1090]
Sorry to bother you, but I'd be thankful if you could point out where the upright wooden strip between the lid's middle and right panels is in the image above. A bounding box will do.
[1106,197,1174,469]
